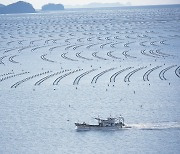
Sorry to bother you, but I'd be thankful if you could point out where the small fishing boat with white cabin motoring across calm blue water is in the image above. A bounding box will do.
[75,116,127,131]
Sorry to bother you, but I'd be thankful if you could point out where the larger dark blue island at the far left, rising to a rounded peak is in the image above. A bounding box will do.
[0,1,36,14]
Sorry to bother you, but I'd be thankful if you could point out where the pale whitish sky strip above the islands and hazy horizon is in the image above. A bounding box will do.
[0,0,180,9]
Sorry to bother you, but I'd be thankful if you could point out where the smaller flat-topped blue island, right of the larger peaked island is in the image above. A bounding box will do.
[42,3,64,11]
